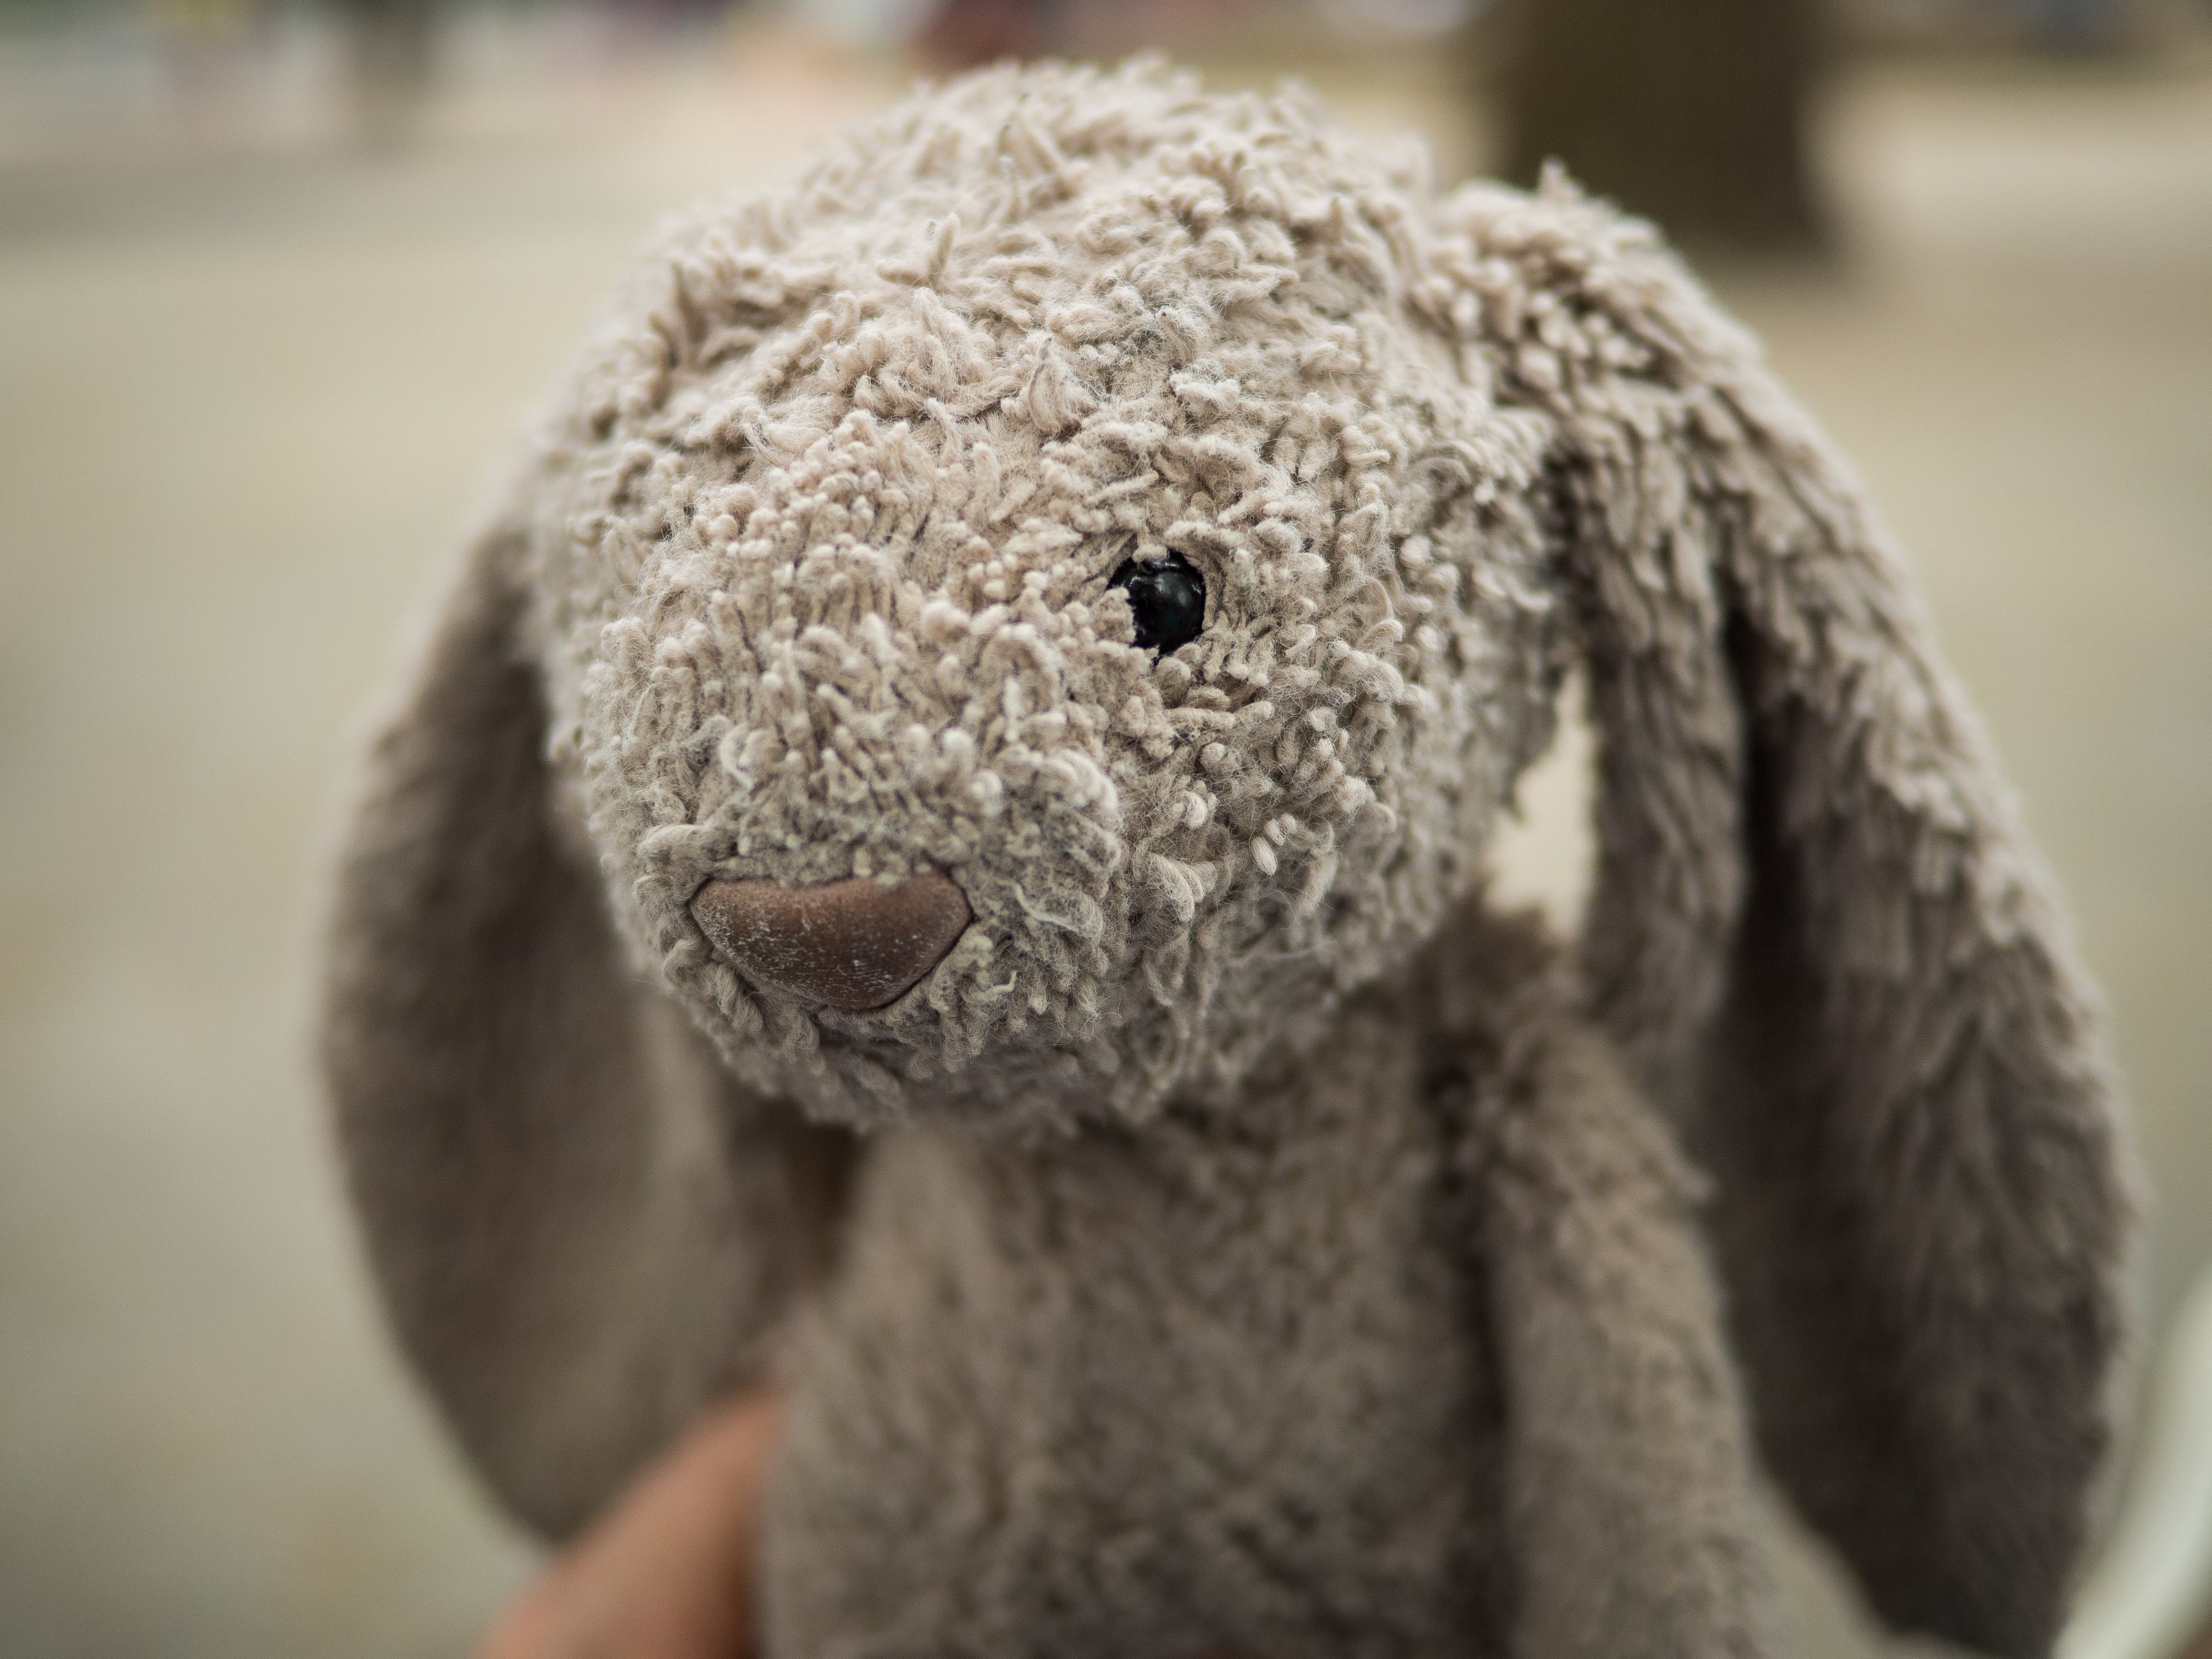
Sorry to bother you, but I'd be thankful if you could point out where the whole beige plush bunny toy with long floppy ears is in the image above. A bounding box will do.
[325,66,2128,1659]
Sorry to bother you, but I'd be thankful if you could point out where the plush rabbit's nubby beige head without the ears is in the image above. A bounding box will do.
[533,73,1557,1121]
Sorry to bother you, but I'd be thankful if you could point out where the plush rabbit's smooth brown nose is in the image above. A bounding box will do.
[692,869,971,1013]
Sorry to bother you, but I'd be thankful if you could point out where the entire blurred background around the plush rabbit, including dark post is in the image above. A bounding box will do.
[0,0,2212,1659]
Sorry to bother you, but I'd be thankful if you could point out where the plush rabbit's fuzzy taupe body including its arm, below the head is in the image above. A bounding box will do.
[767,909,1759,1659]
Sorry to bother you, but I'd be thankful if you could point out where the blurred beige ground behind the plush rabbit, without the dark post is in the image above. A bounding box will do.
[0,16,2212,1659]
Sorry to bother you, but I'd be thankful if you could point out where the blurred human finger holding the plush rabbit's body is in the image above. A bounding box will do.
[476,1389,781,1659]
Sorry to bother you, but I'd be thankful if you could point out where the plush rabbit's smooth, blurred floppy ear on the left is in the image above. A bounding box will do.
[323,513,832,1533]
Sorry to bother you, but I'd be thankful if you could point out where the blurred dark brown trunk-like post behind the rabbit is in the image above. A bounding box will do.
[1504,0,1829,254]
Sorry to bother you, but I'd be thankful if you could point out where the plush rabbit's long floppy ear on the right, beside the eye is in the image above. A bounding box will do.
[1445,179,2128,1657]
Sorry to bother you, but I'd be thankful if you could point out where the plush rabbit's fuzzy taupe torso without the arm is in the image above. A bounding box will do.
[767,960,1502,1659]
